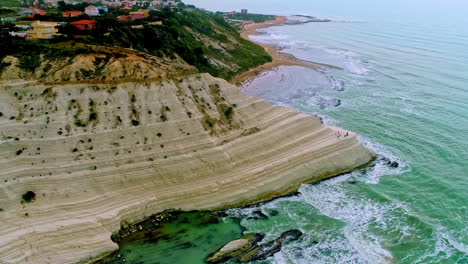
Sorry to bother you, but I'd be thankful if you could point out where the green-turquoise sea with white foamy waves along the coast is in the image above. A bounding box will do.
[107,6,468,264]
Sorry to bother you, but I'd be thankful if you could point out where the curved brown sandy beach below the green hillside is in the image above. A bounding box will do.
[229,16,322,86]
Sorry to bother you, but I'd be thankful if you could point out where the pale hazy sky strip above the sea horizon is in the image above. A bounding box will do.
[185,0,468,20]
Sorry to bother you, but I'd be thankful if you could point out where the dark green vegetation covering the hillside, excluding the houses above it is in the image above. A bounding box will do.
[0,4,271,79]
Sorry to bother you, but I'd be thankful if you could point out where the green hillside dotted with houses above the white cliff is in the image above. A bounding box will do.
[0,0,271,79]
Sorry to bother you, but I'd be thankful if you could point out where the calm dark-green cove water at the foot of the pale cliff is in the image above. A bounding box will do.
[107,212,242,264]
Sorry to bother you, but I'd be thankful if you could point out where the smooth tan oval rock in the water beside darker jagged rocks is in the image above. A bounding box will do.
[206,233,264,263]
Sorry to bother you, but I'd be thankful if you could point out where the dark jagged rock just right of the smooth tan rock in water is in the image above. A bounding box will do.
[238,229,302,262]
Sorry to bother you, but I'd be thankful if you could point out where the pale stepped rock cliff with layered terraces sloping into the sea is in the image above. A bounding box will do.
[0,69,373,264]
